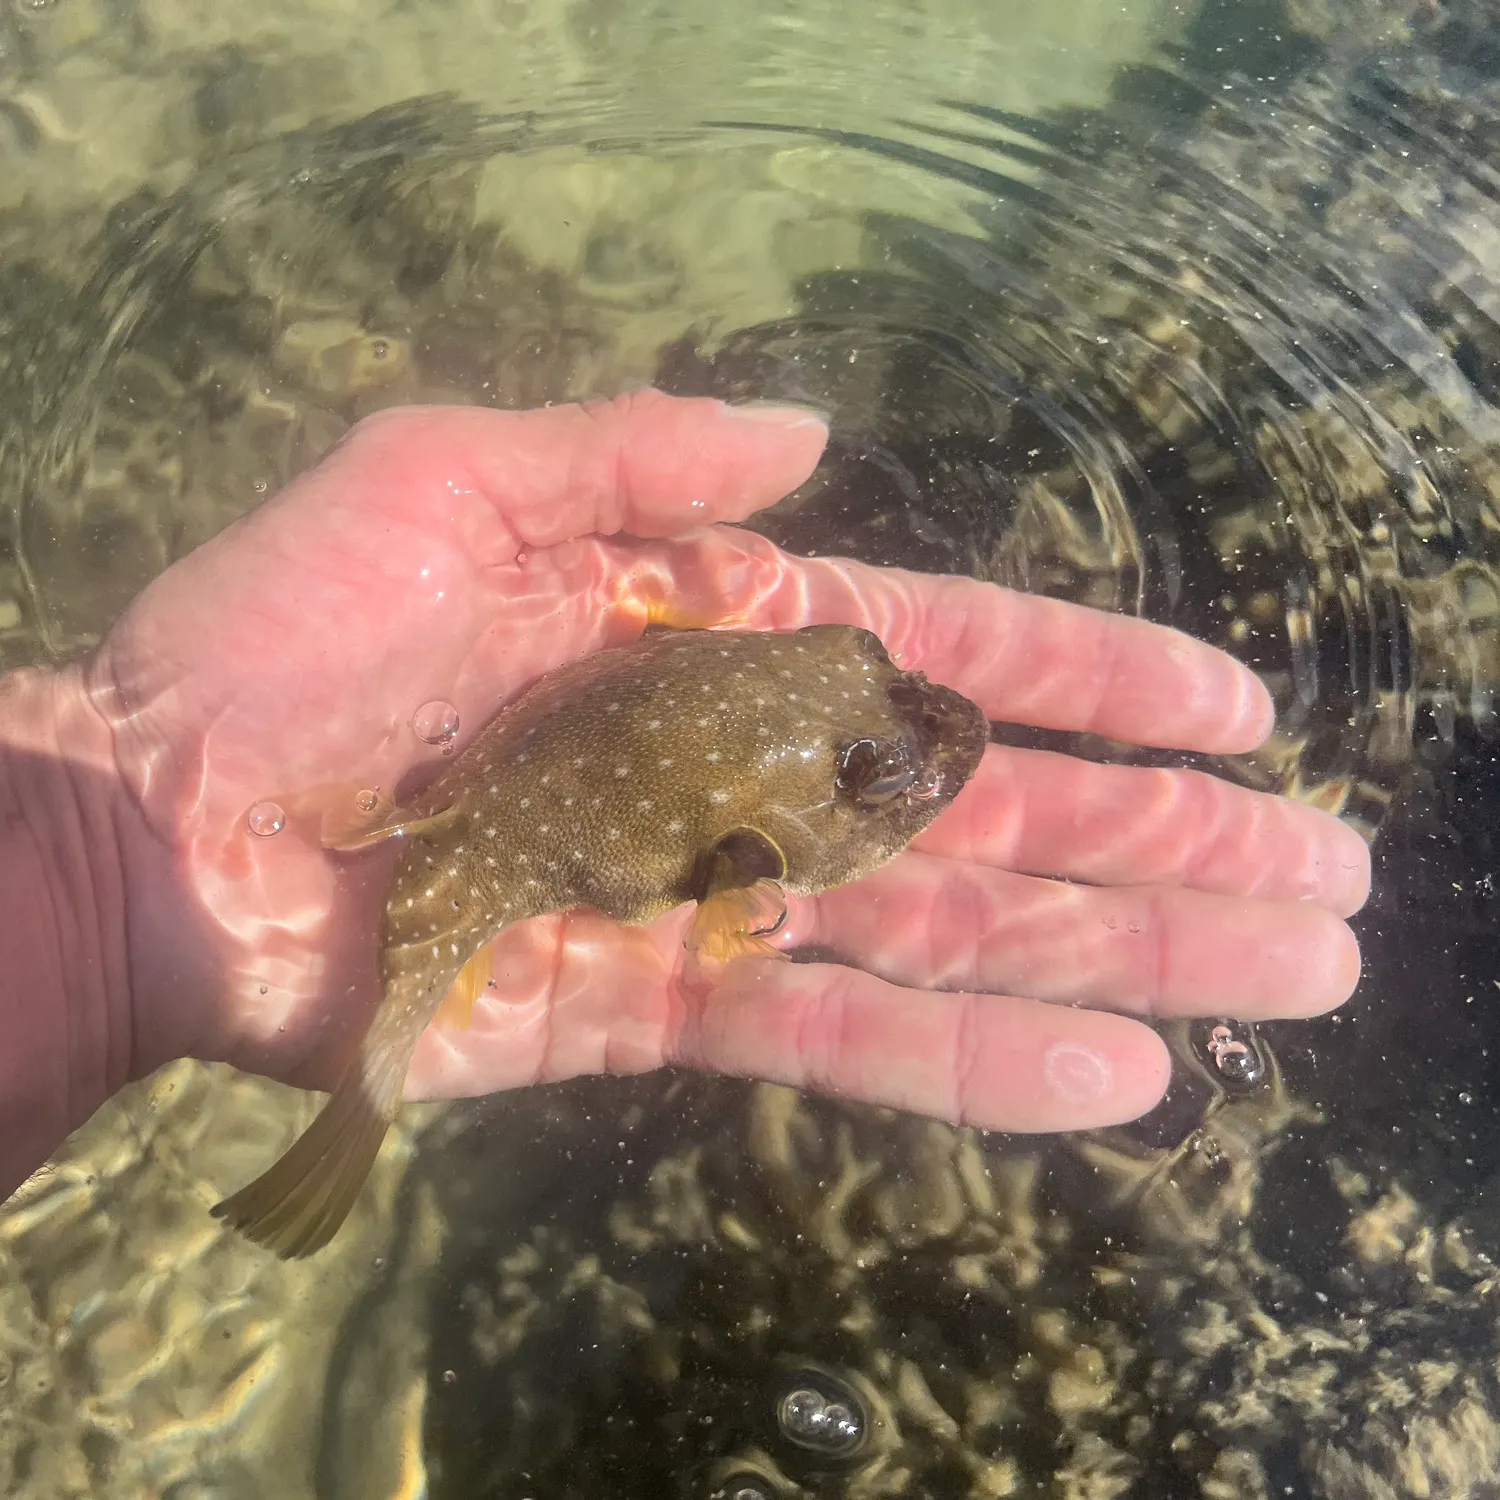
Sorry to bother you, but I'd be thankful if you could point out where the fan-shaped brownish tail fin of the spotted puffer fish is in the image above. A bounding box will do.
[213,1059,402,1260]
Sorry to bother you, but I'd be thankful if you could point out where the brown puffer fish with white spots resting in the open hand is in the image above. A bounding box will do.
[213,626,989,1257]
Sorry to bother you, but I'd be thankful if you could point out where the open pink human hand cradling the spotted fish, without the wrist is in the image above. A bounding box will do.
[81,392,1370,1130]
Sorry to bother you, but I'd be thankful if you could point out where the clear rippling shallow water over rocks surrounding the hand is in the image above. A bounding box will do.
[0,0,1500,1500]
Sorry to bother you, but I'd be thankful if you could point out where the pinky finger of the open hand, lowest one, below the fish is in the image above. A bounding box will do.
[669,960,1170,1131]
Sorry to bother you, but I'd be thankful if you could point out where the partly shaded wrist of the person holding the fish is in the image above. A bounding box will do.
[0,668,134,1197]
